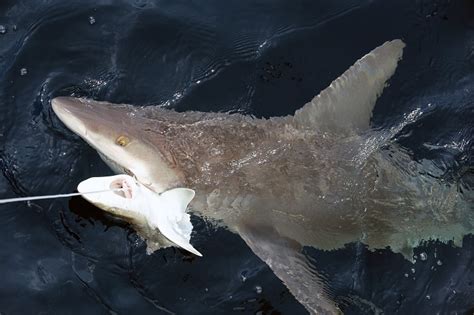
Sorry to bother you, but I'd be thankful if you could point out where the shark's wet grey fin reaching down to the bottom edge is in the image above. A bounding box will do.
[238,224,341,314]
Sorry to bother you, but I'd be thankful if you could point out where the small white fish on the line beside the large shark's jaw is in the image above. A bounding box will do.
[77,174,202,256]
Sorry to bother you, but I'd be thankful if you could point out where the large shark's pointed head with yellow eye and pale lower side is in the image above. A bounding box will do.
[51,97,184,193]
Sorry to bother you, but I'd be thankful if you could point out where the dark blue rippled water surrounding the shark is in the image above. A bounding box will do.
[0,0,474,314]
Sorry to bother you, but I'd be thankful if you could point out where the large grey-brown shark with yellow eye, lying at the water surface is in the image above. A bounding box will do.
[52,40,474,313]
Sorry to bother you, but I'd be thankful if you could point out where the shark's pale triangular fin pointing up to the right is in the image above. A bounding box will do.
[294,39,405,134]
